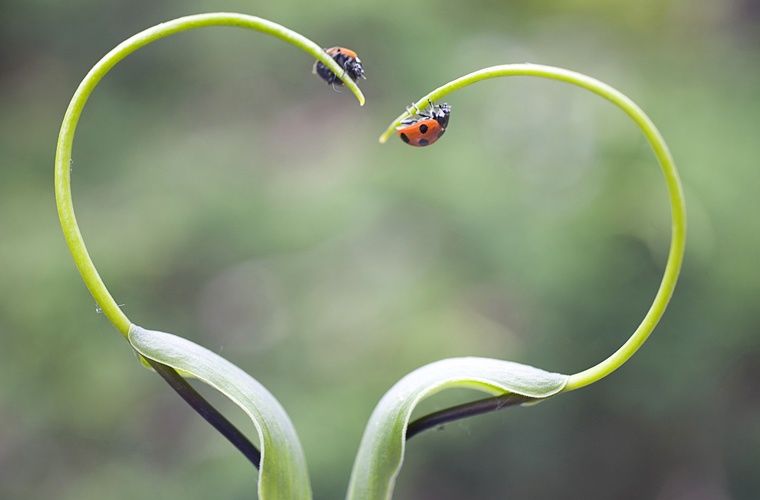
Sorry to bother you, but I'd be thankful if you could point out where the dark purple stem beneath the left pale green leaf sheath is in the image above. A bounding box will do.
[144,358,261,468]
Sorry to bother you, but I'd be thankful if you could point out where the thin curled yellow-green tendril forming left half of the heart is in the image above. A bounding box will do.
[55,12,364,338]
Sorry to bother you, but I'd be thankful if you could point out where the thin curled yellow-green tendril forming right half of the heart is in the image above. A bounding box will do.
[380,64,686,392]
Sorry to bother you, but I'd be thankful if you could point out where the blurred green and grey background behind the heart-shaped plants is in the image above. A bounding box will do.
[0,0,760,500]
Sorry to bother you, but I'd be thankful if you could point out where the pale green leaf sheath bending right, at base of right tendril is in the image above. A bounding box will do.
[347,358,568,500]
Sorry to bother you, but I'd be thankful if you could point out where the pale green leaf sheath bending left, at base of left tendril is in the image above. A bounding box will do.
[129,325,311,500]
